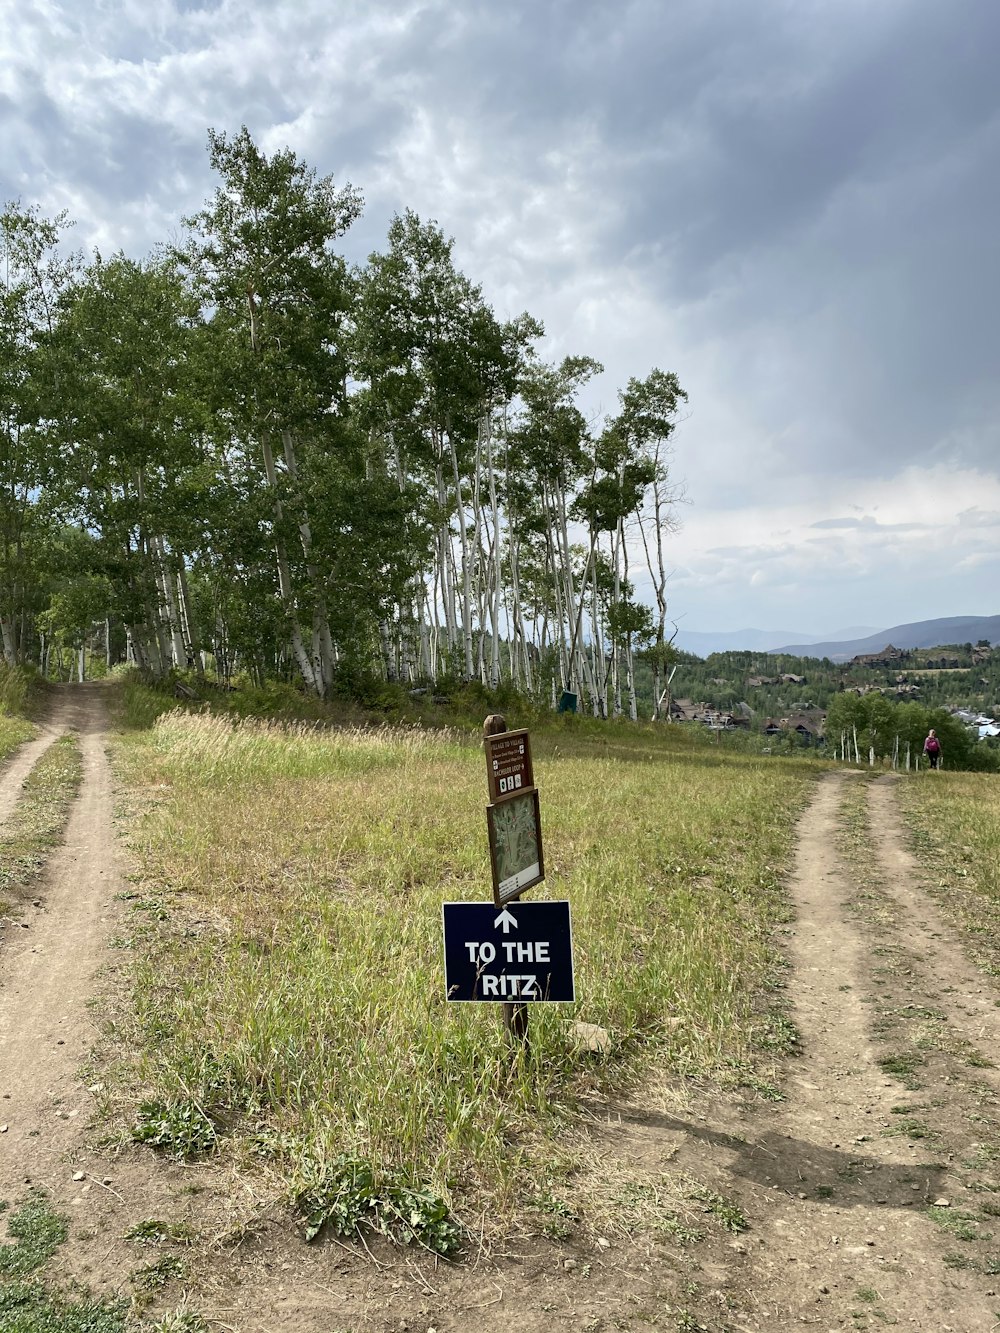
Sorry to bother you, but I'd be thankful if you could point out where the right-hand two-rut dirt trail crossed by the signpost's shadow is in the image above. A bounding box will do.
[618,773,1000,1333]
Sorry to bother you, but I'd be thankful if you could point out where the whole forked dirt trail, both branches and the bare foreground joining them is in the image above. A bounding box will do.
[0,688,1000,1333]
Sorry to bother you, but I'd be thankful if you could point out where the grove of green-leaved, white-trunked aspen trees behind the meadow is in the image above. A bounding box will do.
[0,128,687,717]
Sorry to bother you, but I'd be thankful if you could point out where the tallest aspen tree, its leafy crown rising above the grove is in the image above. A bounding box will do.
[181,127,361,694]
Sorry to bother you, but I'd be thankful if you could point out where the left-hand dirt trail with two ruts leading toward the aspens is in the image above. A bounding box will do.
[0,685,186,1281]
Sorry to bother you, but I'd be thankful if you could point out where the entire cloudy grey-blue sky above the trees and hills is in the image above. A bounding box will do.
[0,0,1000,639]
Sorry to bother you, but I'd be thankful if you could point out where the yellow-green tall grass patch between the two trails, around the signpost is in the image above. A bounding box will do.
[111,712,812,1221]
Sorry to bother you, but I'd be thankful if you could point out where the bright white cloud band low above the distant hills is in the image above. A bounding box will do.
[637,468,1000,629]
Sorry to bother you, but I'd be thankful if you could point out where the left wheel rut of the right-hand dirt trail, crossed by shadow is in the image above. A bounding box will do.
[737,774,993,1329]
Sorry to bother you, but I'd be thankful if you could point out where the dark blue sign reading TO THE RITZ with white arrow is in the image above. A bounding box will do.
[441,902,575,1004]
